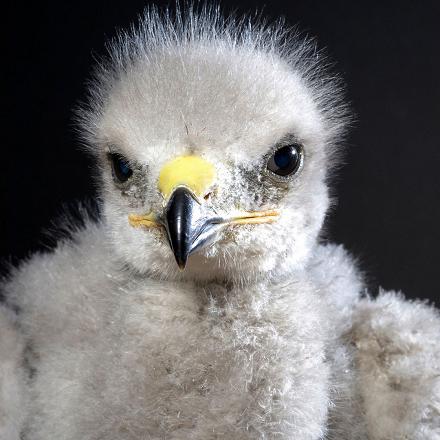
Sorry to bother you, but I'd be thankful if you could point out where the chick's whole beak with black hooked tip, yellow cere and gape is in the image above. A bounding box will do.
[128,156,279,270]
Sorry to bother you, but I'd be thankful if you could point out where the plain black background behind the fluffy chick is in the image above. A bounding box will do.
[0,0,440,301]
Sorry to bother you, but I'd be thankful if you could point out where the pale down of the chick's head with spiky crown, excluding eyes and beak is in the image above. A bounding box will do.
[78,7,348,282]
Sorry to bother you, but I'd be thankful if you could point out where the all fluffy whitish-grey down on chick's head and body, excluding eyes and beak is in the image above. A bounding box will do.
[0,6,440,440]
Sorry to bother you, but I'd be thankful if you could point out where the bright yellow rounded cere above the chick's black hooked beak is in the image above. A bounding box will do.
[158,156,216,200]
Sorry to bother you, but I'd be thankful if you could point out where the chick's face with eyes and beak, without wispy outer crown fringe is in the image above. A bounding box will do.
[89,44,338,282]
